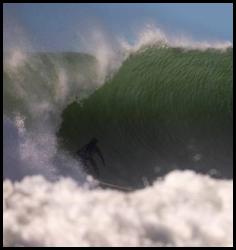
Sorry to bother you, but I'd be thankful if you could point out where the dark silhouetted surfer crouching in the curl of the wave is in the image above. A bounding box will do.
[77,138,105,177]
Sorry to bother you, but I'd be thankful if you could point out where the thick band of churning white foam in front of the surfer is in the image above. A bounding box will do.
[3,171,233,246]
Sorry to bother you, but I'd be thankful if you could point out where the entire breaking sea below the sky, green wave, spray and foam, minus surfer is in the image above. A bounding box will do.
[3,26,233,247]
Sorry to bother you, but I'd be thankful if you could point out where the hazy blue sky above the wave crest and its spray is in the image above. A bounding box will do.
[3,3,233,51]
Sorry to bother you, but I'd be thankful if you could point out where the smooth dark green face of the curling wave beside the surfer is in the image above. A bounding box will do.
[57,46,233,187]
